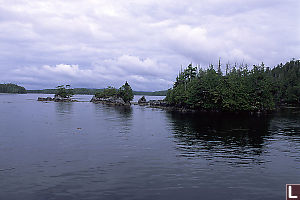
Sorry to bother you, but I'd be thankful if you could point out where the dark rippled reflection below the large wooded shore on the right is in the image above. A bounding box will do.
[167,112,270,164]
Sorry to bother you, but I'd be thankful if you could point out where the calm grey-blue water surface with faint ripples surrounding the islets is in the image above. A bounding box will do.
[0,94,300,200]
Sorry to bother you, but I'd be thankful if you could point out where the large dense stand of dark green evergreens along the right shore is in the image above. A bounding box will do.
[166,60,300,111]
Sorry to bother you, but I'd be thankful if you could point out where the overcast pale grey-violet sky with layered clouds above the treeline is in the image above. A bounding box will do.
[0,0,300,91]
